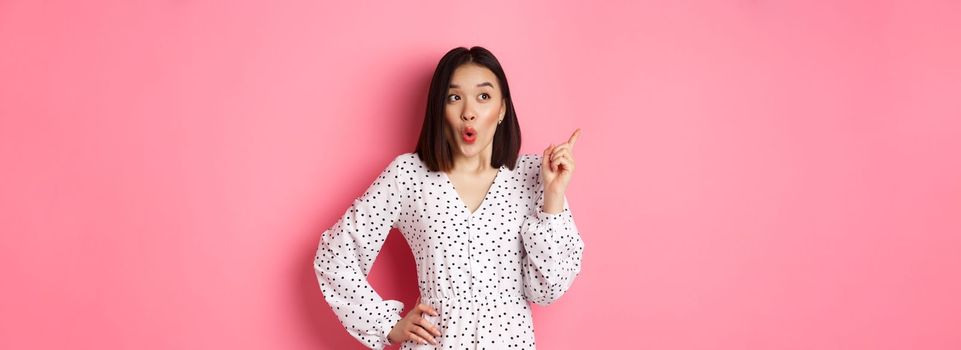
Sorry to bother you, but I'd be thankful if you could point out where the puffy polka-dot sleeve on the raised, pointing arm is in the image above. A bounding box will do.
[521,159,584,305]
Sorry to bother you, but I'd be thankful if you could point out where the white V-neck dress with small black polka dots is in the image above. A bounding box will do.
[313,153,584,349]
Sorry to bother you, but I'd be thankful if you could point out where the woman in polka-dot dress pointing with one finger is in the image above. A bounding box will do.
[313,46,584,349]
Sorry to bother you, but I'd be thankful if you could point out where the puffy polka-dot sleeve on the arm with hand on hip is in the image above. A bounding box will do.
[313,157,410,349]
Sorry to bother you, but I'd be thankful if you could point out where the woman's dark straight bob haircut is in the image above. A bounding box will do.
[415,46,521,172]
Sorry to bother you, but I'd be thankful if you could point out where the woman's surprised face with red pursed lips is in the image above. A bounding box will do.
[444,63,507,157]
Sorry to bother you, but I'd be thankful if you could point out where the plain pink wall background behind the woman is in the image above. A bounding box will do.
[0,0,961,349]
